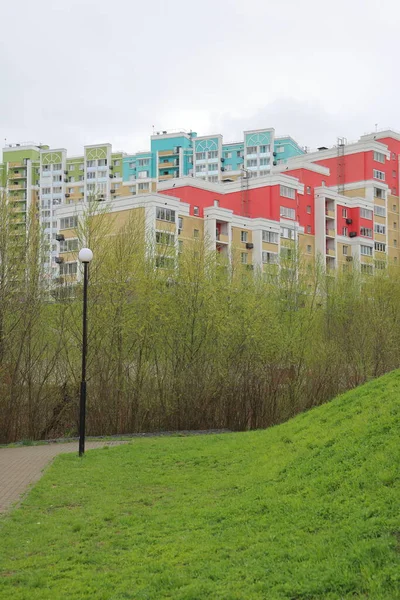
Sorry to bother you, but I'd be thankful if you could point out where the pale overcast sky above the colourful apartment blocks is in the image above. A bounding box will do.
[0,0,400,154]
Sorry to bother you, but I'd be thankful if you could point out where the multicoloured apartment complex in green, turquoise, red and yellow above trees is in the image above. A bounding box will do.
[0,129,400,277]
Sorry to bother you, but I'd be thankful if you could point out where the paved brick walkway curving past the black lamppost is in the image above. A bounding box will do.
[0,442,126,513]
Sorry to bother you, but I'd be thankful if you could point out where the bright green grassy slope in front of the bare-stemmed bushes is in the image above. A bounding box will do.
[0,372,400,600]
